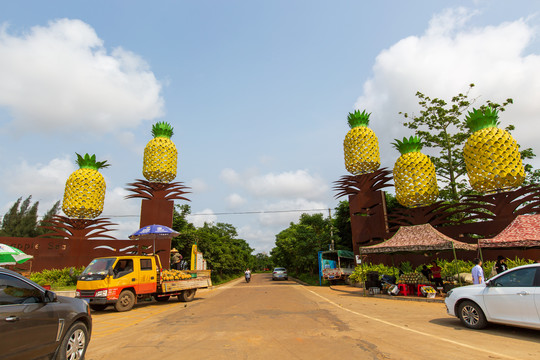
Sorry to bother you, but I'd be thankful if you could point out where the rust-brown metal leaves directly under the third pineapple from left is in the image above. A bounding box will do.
[334,168,392,199]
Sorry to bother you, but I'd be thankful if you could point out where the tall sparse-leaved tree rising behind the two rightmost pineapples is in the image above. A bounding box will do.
[400,84,540,202]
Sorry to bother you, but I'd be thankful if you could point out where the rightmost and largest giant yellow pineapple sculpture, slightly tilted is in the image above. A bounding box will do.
[463,107,525,193]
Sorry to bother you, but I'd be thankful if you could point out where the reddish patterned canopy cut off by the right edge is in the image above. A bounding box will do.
[478,215,540,248]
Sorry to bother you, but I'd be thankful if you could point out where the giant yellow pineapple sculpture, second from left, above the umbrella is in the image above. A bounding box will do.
[143,122,178,183]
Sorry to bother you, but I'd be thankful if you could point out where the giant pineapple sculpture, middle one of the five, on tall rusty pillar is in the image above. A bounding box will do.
[343,110,381,175]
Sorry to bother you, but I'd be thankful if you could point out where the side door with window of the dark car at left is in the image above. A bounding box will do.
[0,274,59,359]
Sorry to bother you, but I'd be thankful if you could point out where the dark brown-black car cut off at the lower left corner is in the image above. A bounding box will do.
[0,267,92,360]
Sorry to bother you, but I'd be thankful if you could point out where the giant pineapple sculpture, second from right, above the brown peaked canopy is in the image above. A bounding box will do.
[392,136,439,208]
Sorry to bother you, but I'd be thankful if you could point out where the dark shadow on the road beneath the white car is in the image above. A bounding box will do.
[429,317,540,344]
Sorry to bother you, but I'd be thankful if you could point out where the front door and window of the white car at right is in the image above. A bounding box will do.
[484,267,540,325]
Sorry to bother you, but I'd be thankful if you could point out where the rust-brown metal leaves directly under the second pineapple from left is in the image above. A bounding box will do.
[126,179,190,201]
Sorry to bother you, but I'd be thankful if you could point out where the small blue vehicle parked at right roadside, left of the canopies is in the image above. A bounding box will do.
[319,250,356,283]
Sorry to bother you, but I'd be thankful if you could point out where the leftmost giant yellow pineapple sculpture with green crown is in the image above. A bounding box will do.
[62,154,109,219]
